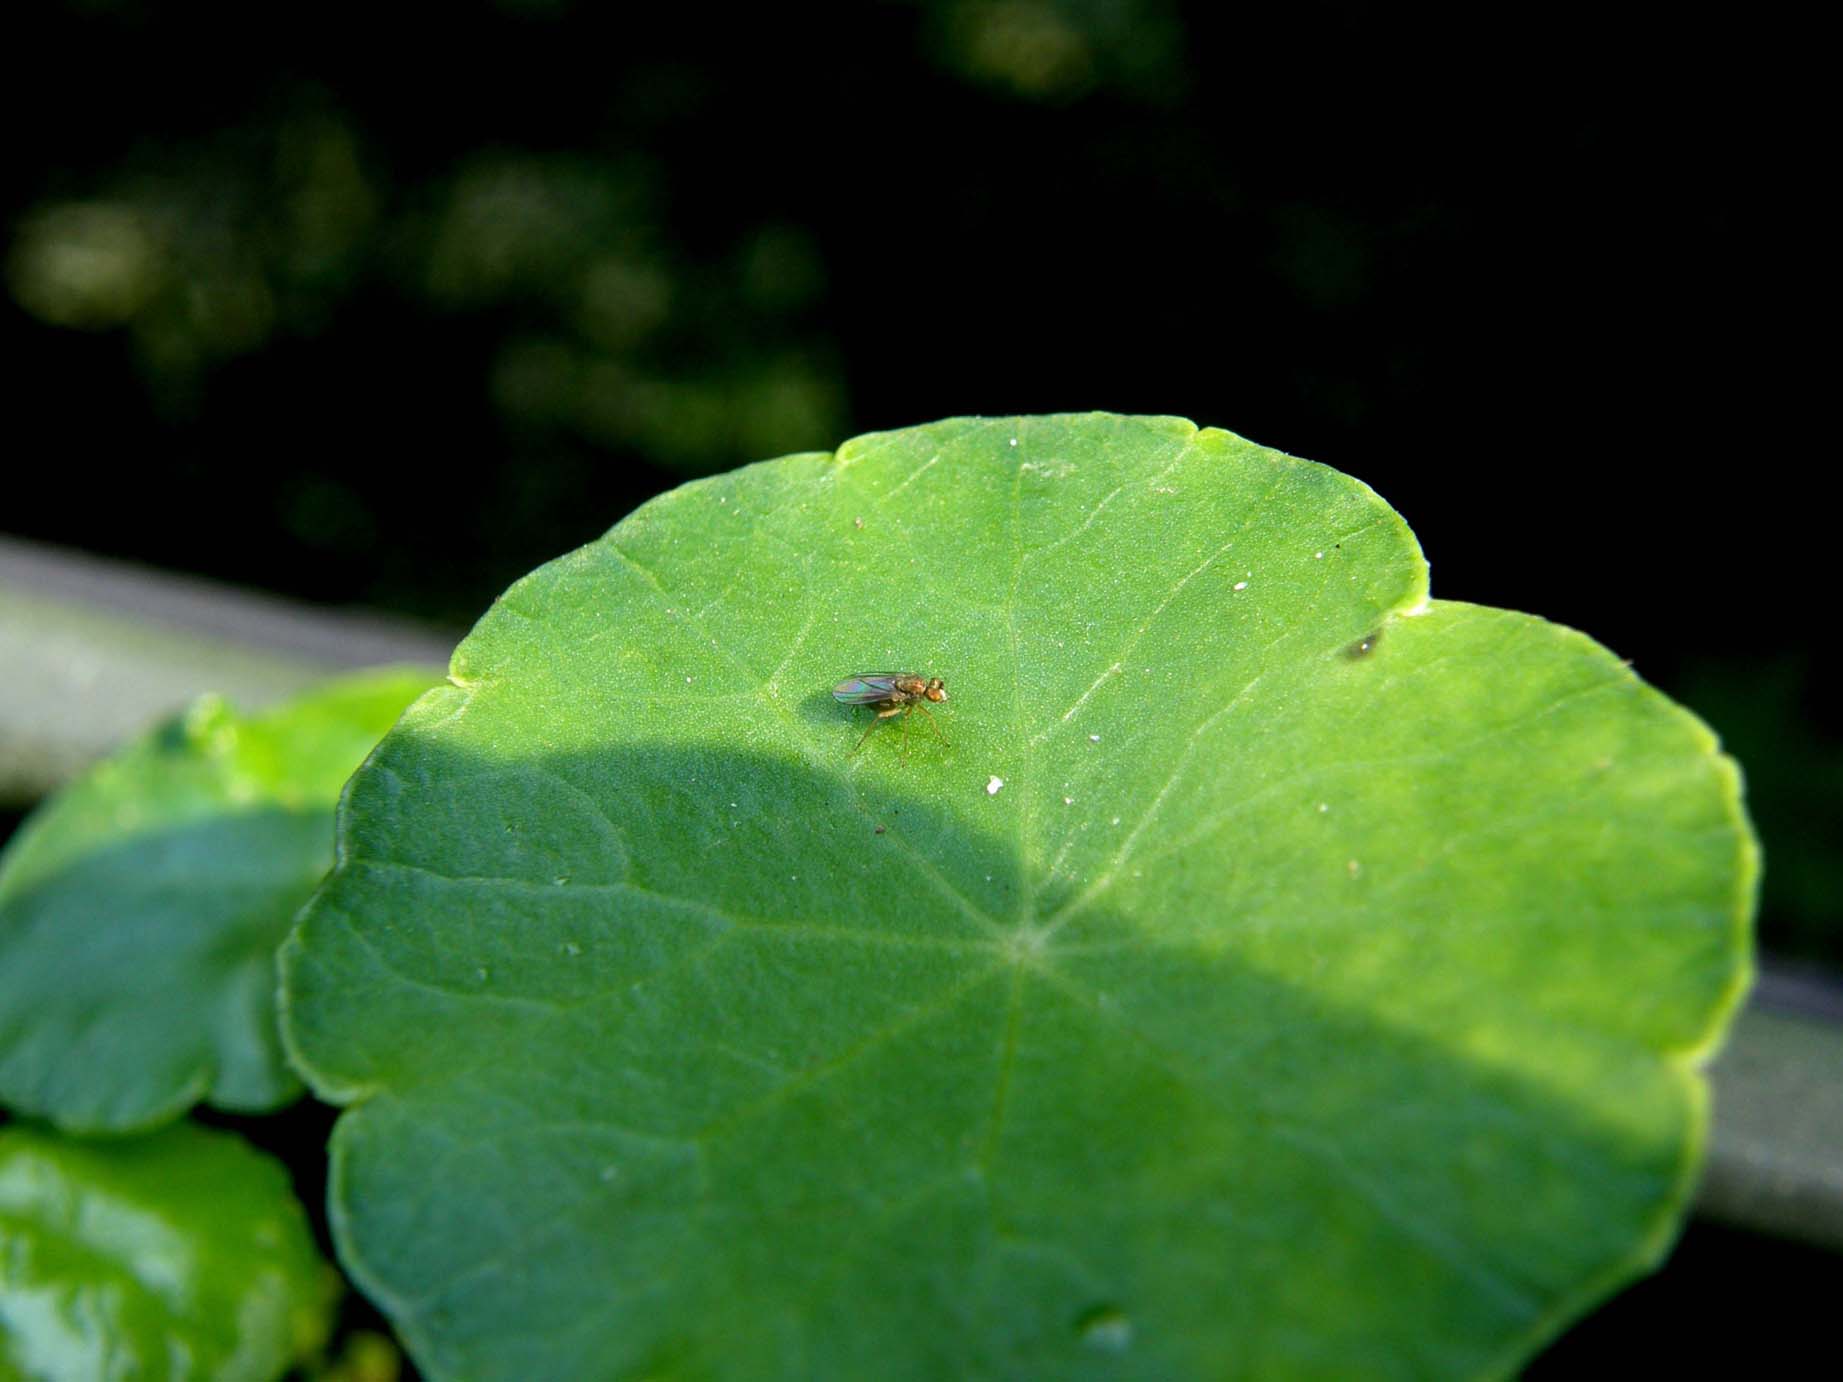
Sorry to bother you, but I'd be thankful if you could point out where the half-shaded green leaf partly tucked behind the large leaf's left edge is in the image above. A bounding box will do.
[0,669,433,1131]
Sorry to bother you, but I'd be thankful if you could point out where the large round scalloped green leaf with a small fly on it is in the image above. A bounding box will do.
[284,416,1755,1378]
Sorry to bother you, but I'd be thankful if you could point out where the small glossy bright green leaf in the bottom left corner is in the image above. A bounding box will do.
[0,1124,339,1382]
